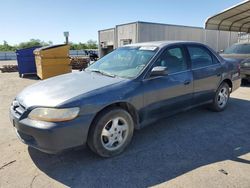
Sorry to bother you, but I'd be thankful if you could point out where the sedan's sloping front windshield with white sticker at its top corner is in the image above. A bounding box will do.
[86,47,157,78]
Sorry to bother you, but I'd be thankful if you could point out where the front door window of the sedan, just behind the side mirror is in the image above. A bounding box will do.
[154,47,187,73]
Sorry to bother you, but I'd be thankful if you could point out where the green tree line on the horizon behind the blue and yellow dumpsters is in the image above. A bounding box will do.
[0,39,98,51]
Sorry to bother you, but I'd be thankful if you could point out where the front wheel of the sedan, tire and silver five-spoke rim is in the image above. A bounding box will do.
[87,108,134,157]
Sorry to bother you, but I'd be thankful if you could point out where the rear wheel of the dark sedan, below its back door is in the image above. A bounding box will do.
[211,82,230,112]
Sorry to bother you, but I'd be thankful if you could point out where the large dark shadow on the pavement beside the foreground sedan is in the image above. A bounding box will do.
[28,98,250,187]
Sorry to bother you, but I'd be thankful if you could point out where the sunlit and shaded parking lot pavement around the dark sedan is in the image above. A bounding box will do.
[0,73,250,188]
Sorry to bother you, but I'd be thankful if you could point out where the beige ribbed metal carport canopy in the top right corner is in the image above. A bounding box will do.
[205,0,250,33]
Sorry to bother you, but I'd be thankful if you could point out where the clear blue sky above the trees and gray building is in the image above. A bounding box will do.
[0,0,242,45]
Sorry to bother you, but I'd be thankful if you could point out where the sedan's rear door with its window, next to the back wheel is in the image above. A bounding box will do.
[187,45,222,104]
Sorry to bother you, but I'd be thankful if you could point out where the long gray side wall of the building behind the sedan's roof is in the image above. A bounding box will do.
[138,22,238,51]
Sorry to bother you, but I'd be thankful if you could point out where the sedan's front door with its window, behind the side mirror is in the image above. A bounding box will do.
[143,46,193,120]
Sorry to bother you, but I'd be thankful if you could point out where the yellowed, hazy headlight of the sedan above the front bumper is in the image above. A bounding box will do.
[28,107,80,122]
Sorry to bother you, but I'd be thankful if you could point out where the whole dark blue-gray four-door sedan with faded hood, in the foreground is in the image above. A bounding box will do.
[10,41,240,157]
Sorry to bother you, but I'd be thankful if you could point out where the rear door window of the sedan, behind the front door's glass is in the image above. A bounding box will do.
[187,46,214,69]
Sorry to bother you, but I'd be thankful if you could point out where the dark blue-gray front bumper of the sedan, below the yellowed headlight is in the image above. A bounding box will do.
[10,109,91,154]
